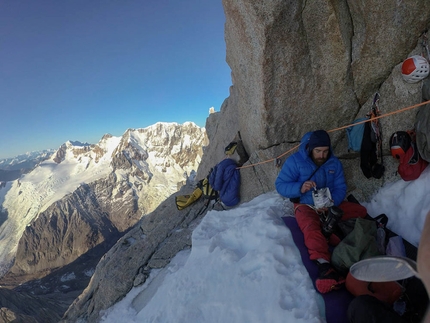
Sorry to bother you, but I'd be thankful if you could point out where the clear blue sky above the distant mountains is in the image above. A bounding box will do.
[0,0,231,158]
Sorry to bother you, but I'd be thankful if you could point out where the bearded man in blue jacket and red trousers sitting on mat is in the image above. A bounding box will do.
[275,130,367,293]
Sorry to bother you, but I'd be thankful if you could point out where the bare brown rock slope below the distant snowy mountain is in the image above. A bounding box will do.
[10,183,127,277]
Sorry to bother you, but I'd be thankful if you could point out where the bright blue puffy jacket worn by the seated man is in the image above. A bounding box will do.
[275,132,346,206]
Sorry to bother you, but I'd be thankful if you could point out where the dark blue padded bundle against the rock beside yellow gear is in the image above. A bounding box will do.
[209,158,240,206]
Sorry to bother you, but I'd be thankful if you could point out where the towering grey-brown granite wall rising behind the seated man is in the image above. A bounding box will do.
[198,0,430,204]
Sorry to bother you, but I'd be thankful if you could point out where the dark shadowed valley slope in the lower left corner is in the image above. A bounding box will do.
[0,232,126,323]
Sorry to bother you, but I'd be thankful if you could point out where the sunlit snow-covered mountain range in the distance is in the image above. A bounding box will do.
[0,123,207,275]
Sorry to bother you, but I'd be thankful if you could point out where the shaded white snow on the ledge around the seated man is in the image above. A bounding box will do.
[101,167,430,323]
